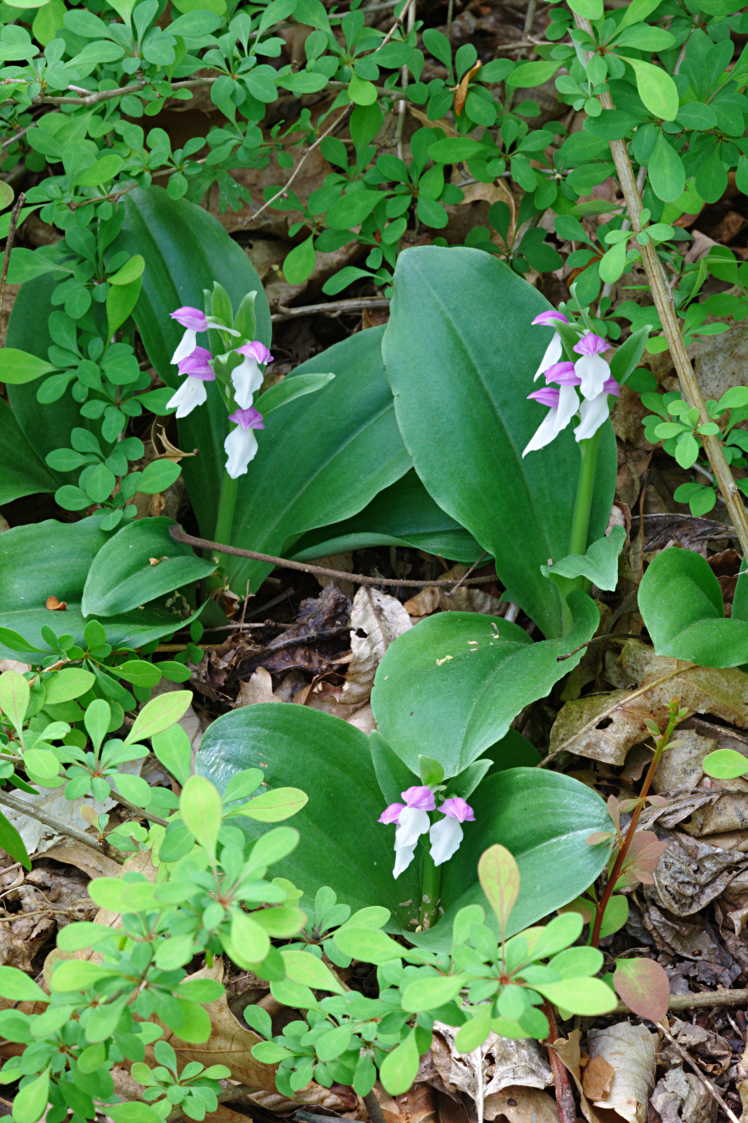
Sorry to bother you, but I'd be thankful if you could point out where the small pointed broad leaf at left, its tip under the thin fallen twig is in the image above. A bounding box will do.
[81,518,216,617]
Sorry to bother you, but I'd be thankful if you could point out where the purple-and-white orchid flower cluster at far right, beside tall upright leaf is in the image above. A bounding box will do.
[522,310,621,456]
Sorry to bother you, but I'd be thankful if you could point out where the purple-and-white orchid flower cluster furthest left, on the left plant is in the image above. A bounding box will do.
[166,304,273,480]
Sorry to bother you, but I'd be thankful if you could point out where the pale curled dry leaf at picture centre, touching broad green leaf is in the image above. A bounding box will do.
[340,585,412,709]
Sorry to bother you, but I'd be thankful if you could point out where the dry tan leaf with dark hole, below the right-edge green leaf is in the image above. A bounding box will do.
[549,640,748,765]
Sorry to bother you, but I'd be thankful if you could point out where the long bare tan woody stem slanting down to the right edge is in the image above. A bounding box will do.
[574,13,748,558]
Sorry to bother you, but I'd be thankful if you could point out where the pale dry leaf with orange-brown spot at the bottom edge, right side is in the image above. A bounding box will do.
[584,1022,657,1123]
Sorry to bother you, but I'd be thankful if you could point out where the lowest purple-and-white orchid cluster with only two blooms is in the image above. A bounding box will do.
[378,784,475,877]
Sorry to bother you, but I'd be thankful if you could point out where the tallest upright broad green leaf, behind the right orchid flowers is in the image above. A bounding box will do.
[383,249,615,636]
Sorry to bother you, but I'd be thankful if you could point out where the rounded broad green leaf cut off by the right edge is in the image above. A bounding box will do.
[638,547,748,667]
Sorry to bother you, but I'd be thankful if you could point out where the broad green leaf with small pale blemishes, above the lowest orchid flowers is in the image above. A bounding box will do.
[372,592,599,777]
